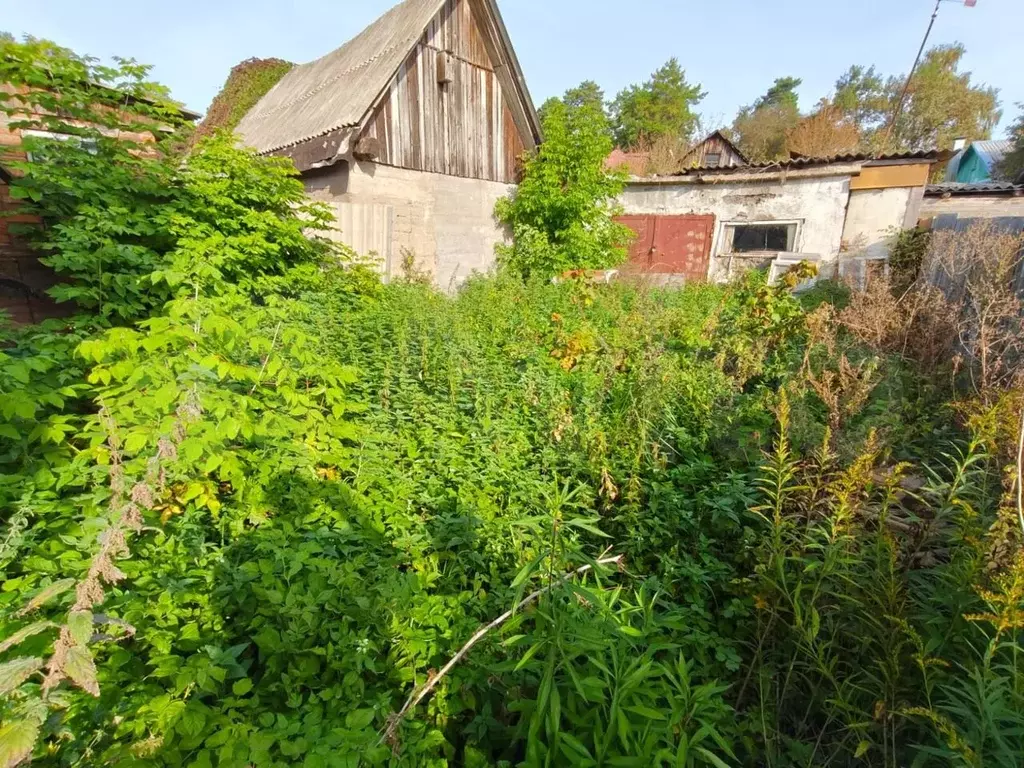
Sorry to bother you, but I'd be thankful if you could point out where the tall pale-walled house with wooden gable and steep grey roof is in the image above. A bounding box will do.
[237,0,541,288]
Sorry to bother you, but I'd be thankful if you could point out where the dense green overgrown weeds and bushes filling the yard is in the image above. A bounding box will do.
[0,39,1024,768]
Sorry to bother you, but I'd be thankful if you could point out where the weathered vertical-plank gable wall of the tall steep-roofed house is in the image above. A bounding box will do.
[362,0,525,183]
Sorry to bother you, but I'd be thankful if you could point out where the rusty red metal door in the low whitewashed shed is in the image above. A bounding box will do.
[617,215,715,282]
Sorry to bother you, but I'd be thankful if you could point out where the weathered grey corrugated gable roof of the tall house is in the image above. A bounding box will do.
[237,0,540,160]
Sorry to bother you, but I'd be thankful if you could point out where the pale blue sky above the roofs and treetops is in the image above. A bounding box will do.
[0,0,1024,137]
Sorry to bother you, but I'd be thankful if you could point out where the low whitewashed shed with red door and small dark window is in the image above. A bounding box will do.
[620,152,941,281]
